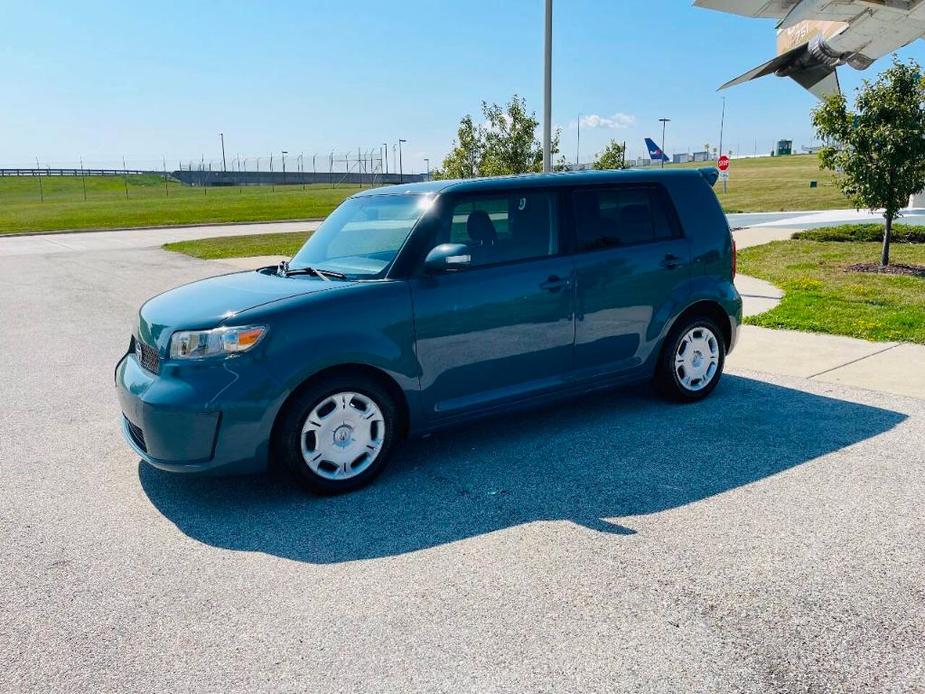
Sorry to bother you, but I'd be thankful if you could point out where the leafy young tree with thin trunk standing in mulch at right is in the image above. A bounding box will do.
[812,56,925,266]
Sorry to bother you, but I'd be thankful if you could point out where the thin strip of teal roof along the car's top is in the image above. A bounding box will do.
[353,167,717,197]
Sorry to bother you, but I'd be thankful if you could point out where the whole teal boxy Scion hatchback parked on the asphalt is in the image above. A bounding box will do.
[115,169,742,493]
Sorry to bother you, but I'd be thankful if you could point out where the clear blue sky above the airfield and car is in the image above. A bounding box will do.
[0,0,925,170]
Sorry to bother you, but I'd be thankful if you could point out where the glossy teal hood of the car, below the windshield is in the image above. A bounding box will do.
[138,270,355,350]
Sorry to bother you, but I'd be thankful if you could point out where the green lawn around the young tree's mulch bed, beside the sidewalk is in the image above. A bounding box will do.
[738,240,925,344]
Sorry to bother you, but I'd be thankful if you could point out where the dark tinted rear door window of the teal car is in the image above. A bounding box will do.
[572,186,680,251]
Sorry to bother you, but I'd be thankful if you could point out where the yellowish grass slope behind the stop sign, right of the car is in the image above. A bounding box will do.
[665,154,852,212]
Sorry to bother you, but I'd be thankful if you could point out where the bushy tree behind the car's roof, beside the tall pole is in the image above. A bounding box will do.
[435,94,559,178]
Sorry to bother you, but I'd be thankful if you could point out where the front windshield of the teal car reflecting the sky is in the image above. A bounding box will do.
[289,195,432,278]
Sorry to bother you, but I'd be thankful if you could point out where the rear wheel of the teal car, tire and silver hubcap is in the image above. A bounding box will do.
[654,316,726,402]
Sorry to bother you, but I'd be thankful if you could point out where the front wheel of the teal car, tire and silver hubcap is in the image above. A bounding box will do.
[275,376,398,494]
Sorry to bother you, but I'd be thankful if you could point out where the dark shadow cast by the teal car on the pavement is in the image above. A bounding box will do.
[138,375,905,563]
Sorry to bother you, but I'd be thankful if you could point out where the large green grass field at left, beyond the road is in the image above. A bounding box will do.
[0,175,359,234]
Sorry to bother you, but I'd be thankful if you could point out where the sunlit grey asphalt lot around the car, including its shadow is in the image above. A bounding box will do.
[0,240,925,692]
